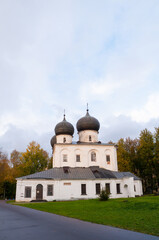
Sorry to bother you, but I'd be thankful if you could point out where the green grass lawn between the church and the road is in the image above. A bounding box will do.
[11,196,159,236]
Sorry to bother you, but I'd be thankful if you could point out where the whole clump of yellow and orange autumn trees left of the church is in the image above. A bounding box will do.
[0,142,51,198]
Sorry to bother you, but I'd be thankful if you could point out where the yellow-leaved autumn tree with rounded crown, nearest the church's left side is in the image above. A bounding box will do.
[20,141,49,175]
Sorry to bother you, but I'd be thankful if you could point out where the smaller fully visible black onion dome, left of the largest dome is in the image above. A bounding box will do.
[55,115,74,136]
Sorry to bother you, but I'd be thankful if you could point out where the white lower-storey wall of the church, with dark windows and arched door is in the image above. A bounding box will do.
[16,177,142,202]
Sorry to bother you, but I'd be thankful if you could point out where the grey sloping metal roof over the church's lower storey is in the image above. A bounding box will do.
[18,166,140,180]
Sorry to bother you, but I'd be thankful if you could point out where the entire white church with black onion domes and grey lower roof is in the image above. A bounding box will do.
[16,109,143,202]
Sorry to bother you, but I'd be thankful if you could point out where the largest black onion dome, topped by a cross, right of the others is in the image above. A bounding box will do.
[76,109,100,132]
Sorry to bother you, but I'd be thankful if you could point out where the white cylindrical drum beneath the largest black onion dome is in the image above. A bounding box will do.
[78,130,98,143]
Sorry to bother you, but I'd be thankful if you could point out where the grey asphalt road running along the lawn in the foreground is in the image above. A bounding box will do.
[0,201,159,240]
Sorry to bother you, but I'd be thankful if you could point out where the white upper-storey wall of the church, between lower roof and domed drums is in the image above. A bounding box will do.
[53,144,118,171]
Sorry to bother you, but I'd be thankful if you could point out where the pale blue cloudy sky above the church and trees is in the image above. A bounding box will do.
[0,0,159,157]
